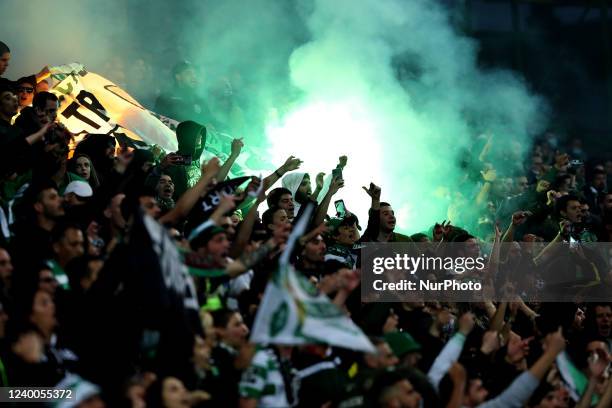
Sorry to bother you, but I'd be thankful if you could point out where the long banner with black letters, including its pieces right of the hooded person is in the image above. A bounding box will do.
[50,63,274,177]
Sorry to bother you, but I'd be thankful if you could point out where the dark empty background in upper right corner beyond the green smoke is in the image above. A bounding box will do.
[443,0,612,151]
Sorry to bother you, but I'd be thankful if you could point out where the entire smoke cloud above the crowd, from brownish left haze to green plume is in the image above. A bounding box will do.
[5,0,546,232]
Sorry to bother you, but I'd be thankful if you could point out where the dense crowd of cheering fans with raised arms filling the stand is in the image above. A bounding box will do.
[0,42,612,408]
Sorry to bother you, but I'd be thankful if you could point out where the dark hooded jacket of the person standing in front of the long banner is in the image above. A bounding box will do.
[165,120,206,200]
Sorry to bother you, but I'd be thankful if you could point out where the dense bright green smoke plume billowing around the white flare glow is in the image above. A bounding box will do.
[271,0,543,232]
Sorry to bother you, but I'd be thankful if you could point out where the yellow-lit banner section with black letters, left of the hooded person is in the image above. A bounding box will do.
[50,63,178,151]
